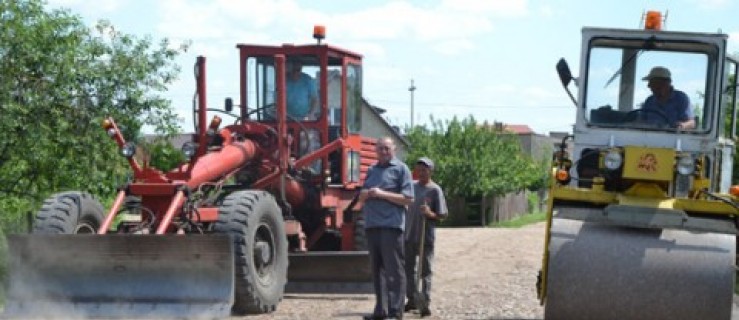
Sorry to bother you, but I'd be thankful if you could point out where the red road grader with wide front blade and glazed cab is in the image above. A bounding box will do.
[5,27,375,318]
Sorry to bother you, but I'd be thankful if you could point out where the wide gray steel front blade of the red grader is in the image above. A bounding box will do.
[4,235,234,319]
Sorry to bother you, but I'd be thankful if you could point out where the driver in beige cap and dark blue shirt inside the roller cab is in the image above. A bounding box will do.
[642,67,695,129]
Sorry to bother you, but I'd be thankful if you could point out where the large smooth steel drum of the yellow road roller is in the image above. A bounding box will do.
[545,218,735,320]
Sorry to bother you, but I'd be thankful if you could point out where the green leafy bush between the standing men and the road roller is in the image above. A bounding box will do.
[407,116,545,197]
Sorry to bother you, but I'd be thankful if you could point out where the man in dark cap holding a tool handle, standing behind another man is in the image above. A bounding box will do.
[404,157,448,317]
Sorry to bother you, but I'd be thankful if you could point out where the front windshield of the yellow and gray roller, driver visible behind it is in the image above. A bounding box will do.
[584,39,713,132]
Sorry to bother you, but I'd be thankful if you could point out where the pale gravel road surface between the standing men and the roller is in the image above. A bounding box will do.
[246,223,544,320]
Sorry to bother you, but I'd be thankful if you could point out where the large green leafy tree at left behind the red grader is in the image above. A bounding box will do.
[0,0,186,230]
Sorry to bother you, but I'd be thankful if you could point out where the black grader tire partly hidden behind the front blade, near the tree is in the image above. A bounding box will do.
[31,191,104,234]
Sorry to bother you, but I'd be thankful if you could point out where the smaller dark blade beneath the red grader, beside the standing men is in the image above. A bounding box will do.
[285,251,374,293]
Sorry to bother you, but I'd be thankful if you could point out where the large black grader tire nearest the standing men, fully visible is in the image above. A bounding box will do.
[213,190,288,315]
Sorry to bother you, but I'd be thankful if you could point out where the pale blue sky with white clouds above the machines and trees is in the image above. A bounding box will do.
[48,0,739,134]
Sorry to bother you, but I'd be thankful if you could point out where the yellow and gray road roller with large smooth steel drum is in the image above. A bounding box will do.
[538,12,739,320]
